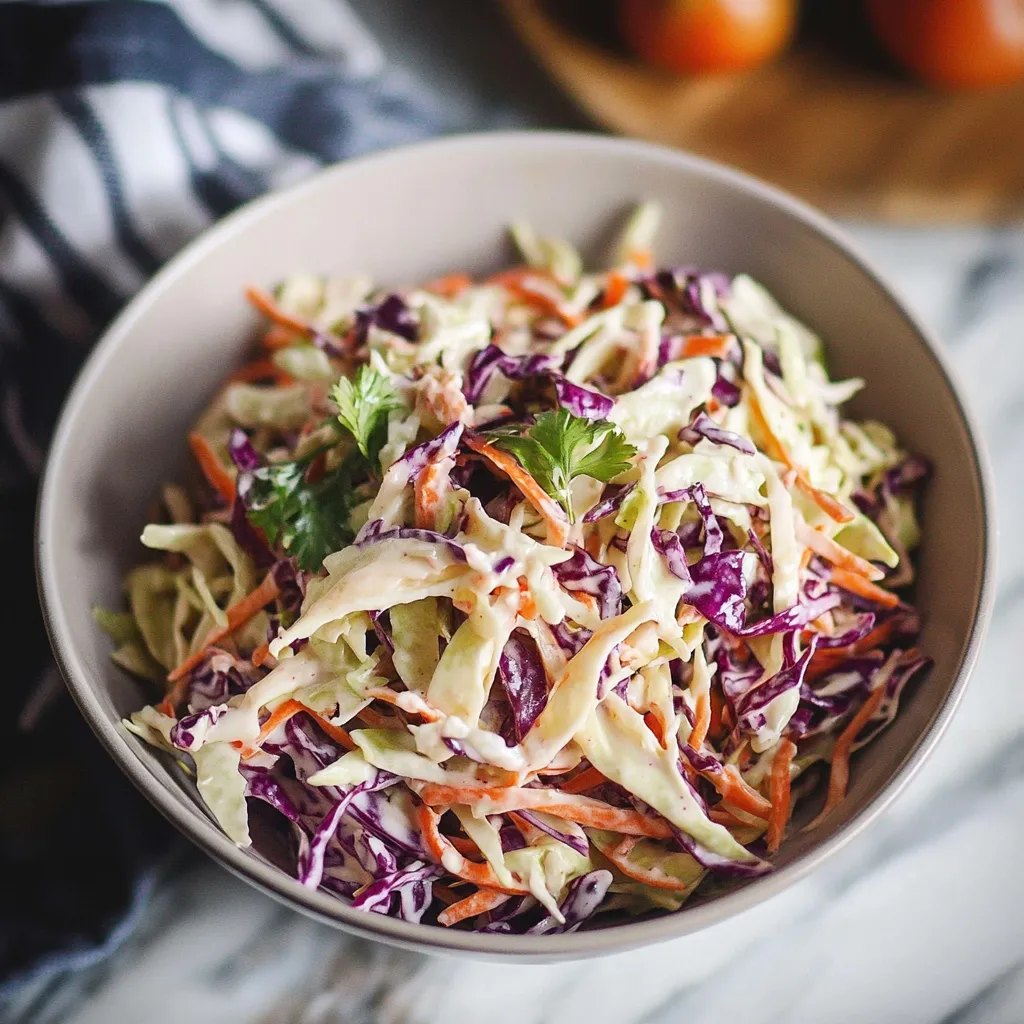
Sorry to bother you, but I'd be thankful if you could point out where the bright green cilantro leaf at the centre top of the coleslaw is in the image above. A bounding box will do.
[489,409,637,522]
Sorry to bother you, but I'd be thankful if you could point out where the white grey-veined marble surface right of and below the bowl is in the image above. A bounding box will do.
[12,225,1024,1024]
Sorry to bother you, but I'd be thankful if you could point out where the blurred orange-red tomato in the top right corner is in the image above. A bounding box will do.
[867,0,1024,88]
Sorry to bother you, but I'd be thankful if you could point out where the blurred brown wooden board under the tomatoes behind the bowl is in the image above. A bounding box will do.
[504,0,1024,223]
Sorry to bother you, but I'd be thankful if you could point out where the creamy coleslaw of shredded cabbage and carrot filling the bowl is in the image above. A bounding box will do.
[96,204,929,934]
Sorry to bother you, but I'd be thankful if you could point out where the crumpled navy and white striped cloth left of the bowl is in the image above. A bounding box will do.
[0,0,449,1013]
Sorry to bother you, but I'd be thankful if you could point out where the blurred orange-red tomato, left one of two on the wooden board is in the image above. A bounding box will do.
[618,0,797,74]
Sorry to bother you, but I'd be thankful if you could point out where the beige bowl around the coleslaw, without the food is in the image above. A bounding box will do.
[39,134,989,955]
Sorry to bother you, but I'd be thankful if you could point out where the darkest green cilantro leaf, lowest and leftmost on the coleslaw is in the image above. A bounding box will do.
[239,460,360,571]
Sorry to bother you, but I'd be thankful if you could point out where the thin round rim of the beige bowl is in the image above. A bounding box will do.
[35,130,996,961]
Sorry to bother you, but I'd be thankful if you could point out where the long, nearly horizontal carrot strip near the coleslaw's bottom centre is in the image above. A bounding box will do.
[420,782,672,839]
